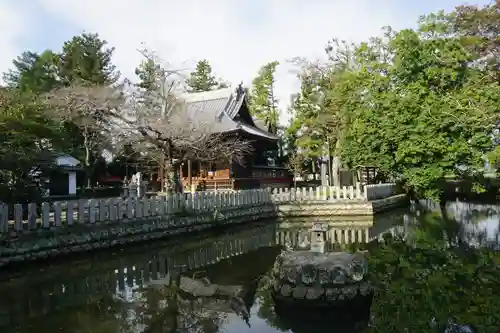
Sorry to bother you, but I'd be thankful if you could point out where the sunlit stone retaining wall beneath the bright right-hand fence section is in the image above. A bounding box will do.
[278,194,409,218]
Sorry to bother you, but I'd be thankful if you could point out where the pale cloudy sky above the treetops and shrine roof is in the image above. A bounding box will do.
[0,0,489,121]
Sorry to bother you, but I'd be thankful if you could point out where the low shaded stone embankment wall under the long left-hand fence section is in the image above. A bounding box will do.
[0,204,276,267]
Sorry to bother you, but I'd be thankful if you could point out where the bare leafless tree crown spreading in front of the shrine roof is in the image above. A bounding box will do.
[42,51,252,174]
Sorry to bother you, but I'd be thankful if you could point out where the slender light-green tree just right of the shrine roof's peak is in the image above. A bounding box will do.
[250,61,279,133]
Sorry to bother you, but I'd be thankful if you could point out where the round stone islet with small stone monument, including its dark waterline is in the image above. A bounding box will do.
[272,224,373,320]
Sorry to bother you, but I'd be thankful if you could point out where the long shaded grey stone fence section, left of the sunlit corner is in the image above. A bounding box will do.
[0,189,272,235]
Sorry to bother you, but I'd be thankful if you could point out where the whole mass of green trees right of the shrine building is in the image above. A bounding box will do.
[290,4,500,197]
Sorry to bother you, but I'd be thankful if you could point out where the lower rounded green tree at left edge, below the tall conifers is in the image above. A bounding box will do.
[0,89,61,203]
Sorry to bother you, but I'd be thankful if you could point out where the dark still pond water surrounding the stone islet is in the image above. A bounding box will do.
[0,202,500,333]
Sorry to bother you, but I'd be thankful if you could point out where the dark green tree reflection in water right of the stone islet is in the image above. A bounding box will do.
[370,212,500,333]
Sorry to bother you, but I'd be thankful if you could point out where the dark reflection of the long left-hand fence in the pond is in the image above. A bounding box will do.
[0,226,274,331]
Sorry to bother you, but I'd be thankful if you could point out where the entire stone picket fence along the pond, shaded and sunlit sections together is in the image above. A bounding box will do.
[0,184,396,235]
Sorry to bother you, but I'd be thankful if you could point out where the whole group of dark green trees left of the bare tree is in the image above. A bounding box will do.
[0,34,119,202]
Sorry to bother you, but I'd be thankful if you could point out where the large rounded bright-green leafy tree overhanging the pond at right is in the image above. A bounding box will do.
[329,18,500,197]
